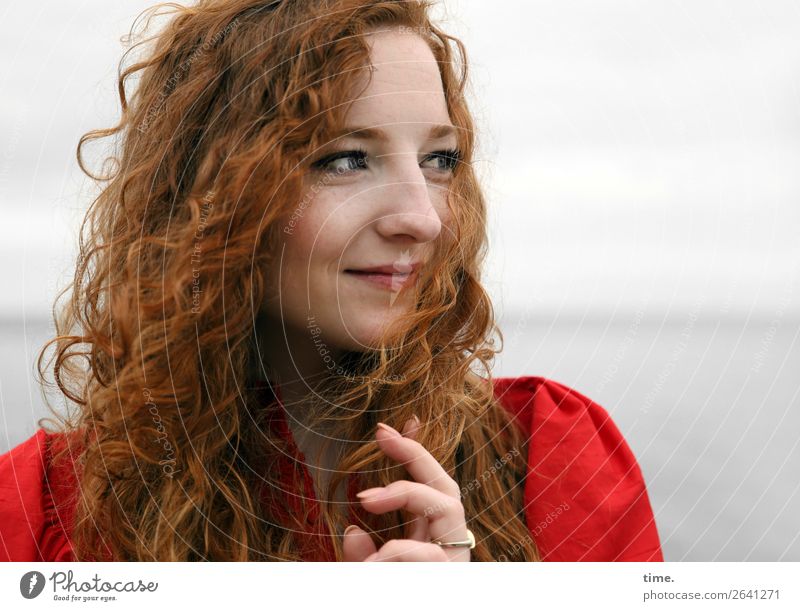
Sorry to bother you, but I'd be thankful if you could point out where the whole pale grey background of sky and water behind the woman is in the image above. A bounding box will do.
[0,0,800,561]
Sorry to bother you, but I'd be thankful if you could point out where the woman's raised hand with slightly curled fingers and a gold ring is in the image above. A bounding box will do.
[343,417,470,562]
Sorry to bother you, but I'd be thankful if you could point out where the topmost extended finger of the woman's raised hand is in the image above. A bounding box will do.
[375,422,461,499]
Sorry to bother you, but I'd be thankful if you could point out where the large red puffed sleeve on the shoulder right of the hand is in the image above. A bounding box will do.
[493,376,663,561]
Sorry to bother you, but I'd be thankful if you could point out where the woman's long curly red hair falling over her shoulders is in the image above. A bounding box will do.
[38,0,539,561]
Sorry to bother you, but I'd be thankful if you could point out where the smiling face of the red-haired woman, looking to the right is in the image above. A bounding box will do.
[265,30,457,354]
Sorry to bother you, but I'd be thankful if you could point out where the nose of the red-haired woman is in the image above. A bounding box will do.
[375,167,446,242]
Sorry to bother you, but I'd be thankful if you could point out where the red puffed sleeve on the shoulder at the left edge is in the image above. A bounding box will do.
[0,428,76,562]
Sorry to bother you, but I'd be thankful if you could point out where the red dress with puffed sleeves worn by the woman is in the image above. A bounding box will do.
[0,376,663,562]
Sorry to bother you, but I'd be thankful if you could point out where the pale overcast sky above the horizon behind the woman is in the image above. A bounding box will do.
[0,0,800,317]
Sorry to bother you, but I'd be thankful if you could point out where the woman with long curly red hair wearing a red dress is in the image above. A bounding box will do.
[0,0,662,561]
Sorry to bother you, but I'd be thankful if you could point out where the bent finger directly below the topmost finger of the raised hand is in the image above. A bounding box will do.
[356,479,467,541]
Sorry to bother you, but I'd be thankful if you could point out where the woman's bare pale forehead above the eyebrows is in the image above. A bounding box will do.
[347,30,450,126]
